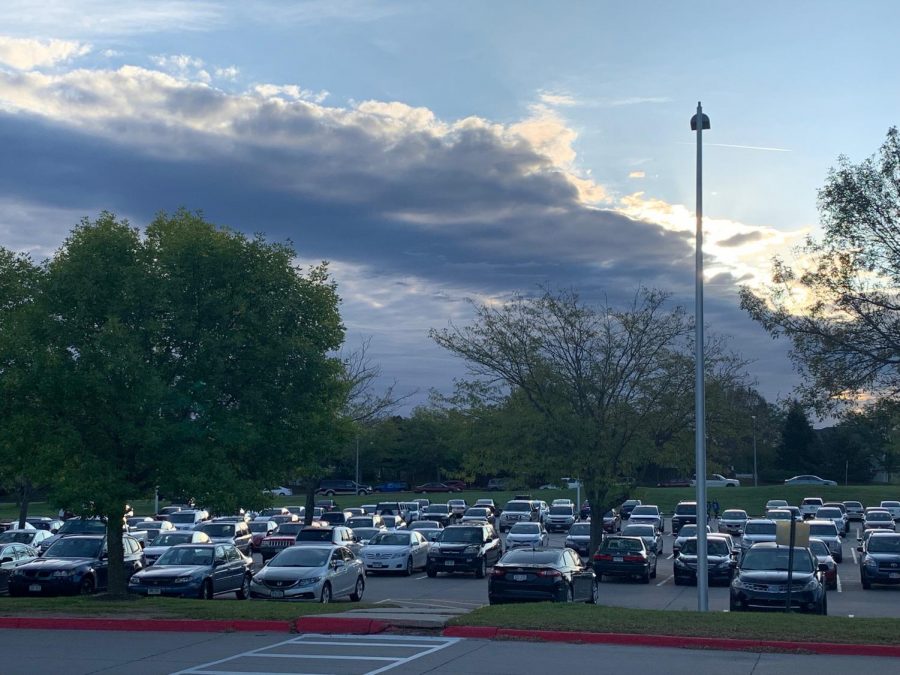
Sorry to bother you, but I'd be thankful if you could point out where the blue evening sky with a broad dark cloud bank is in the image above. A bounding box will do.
[0,0,900,412]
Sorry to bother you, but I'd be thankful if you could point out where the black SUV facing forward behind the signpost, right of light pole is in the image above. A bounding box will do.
[729,542,828,614]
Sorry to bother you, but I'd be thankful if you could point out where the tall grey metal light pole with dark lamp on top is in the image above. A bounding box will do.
[691,101,709,612]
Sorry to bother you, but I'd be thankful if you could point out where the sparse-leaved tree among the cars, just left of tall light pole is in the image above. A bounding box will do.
[431,289,690,546]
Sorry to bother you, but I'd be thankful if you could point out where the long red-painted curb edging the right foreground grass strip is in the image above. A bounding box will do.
[441,626,900,658]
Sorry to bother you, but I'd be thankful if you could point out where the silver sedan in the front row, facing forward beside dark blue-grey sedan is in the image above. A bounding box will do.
[250,545,366,604]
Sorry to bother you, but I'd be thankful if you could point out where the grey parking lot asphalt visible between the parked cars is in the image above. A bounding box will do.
[241,520,900,618]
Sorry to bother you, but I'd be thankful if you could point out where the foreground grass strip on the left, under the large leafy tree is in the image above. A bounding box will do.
[0,595,384,621]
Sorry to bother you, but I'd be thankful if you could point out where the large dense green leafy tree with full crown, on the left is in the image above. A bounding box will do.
[4,211,345,594]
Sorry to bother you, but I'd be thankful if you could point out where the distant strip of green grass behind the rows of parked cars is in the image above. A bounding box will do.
[0,485,900,520]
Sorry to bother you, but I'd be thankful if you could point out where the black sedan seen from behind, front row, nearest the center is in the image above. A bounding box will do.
[488,548,599,605]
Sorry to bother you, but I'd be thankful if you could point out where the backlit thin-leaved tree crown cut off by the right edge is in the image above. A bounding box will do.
[741,127,900,410]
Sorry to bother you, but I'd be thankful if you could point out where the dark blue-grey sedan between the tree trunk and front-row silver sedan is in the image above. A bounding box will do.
[128,543,253,600]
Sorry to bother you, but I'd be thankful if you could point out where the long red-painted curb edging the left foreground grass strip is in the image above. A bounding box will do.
[0,617,291,633]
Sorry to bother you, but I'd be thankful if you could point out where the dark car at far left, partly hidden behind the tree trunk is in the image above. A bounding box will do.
[9,534,143,596]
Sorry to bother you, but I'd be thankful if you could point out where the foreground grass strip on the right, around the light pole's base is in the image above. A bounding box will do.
[450,603,897,645]
